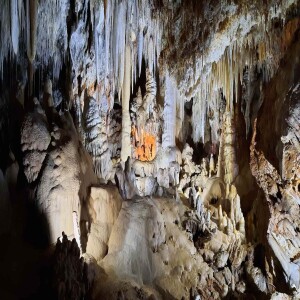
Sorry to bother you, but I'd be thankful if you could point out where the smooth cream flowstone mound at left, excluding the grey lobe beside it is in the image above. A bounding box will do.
[37,108,97,244]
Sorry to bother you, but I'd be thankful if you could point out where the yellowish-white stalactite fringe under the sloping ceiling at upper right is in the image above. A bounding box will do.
[190,3,299,141]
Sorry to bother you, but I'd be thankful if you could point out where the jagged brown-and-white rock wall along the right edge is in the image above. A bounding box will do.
[250,81,300,289]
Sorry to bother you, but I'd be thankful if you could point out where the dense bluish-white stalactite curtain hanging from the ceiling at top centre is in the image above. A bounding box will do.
[95,0,162,104]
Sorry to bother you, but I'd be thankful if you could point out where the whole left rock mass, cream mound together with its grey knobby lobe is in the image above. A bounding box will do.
[21,84,97,247]
